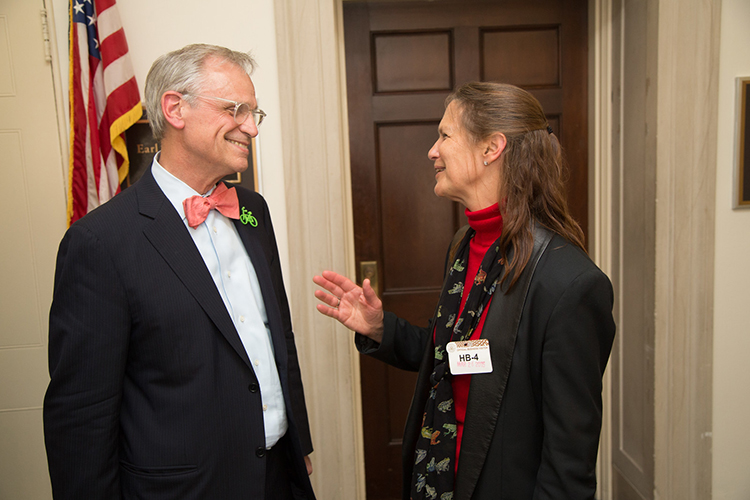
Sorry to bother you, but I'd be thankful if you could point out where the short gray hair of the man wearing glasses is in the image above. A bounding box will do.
[145,43,256,141]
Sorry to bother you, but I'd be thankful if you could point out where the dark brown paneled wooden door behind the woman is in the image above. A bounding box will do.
[344,0,588,500]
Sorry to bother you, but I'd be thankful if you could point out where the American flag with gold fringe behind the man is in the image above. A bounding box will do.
[68,0,143,224]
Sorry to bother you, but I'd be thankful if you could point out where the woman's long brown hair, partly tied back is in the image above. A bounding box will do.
[445,82,586,290]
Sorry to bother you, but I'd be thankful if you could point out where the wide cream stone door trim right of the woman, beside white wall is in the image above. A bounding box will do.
[654,0,721,500]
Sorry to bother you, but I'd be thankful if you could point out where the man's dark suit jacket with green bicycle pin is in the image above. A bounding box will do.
[44,170,314,500]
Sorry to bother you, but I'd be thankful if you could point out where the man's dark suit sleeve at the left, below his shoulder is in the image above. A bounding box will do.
[43,225,130,500]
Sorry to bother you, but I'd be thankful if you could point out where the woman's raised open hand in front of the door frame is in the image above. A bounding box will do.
[313,271,383,342]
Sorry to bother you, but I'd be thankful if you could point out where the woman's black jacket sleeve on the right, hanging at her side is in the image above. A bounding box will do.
[533,269,615,500]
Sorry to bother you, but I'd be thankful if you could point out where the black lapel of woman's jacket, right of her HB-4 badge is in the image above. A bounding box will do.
[456,226,553,500]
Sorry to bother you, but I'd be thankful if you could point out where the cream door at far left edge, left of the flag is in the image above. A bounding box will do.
[0,0,66,500]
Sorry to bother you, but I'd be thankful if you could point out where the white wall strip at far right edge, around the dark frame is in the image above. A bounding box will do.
[713,0,750,500]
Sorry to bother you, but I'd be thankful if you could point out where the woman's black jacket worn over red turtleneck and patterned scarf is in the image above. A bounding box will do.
[357,235,615,500]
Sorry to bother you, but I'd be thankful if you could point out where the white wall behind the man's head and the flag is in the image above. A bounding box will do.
[51,0,289,290]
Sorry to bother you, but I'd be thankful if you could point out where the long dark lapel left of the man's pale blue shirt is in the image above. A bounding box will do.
[132,169,252,368]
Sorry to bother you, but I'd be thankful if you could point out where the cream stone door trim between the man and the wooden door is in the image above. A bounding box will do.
[274,0,365,500]
